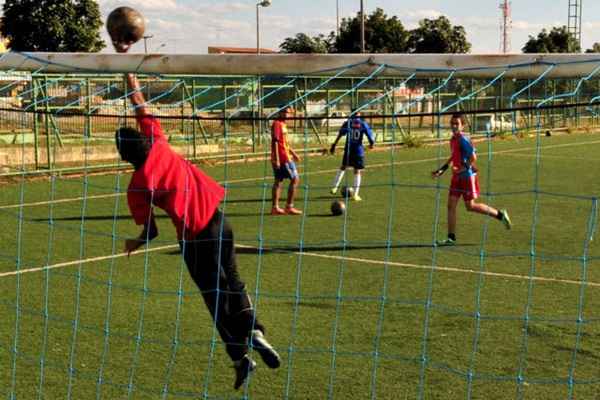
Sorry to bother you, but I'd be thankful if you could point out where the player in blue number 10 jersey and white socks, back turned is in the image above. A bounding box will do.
[329,111,375,201]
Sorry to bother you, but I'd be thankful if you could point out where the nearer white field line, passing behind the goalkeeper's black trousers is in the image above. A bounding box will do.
[0,244,600,287]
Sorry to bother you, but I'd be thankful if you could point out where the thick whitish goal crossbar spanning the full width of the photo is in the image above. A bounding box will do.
[0,52,600,79]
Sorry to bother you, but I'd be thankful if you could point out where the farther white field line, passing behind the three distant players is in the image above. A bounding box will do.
[0,140,600,210]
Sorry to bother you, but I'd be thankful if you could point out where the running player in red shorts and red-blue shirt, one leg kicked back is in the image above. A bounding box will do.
[431,113,512,245]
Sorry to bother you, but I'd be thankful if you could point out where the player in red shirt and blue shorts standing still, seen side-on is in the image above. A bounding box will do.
[271,106,302,215]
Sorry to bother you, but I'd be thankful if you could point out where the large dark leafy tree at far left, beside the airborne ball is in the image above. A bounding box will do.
[0,0,105,52]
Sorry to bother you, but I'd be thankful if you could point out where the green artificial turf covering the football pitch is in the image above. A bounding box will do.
[0,134,600,399]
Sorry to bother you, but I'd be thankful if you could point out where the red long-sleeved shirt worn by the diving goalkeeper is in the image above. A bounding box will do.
[127,116,225,240]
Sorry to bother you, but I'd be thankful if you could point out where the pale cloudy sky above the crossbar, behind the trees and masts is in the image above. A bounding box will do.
[0,0,600,53]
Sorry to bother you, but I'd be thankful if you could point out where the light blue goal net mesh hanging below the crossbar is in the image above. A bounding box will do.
[0,54,600,399]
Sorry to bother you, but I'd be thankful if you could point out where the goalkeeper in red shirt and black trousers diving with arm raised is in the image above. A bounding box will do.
[115,68,280,389]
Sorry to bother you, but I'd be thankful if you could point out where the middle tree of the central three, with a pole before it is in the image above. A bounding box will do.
[332,8,409,53]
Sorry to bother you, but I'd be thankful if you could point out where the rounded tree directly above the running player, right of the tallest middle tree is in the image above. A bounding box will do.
[410,16,471,53]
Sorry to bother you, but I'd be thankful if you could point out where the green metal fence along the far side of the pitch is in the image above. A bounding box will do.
[0,72,600,172]
